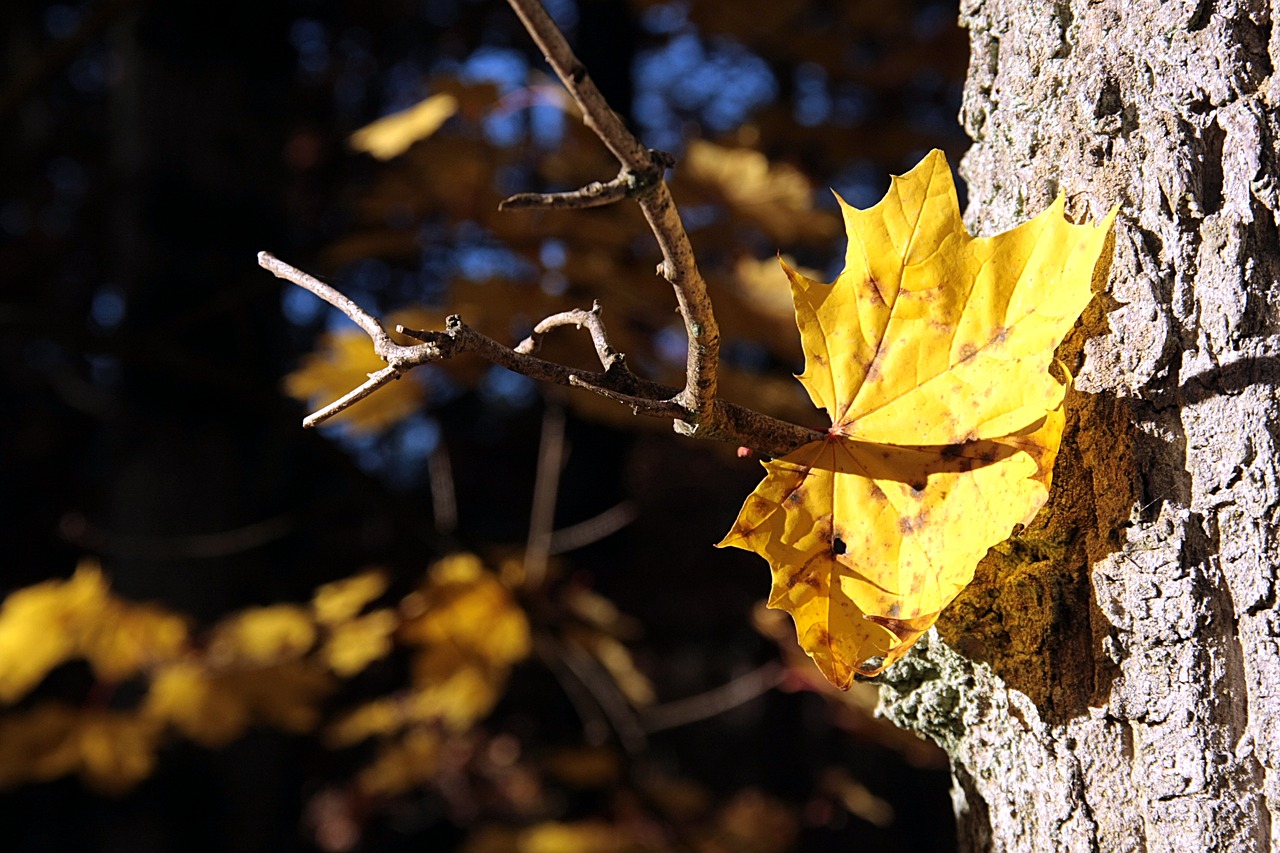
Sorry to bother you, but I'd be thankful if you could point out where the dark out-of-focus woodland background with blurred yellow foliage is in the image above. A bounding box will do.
[0,0,966,853]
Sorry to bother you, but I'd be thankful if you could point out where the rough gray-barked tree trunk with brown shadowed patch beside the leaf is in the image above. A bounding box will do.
[882,0,1280,853]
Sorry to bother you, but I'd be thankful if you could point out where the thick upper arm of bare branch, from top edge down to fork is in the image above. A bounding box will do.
[508,0,719,425]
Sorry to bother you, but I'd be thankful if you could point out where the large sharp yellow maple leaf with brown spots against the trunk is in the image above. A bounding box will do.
[719,151,1115,688]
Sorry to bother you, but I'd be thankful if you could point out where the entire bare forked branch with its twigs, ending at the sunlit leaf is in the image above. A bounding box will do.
[259,0,822,456]
